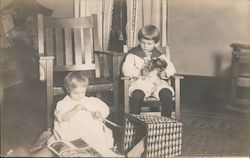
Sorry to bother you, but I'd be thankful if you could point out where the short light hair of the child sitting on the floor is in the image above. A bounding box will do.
[64,71,89,92]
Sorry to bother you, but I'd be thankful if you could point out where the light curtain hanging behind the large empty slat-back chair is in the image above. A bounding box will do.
[74,0,114,50]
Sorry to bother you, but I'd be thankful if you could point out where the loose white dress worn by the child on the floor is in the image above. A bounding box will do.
[49,96,113,156]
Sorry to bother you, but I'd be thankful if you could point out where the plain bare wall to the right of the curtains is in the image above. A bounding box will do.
[168,0,250,76]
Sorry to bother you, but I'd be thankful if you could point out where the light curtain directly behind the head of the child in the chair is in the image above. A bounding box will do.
[126,0,168,46]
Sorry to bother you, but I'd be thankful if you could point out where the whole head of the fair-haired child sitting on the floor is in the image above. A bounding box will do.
[64,71,89,101]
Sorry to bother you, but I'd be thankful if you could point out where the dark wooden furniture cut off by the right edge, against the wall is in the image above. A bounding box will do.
[227,43,250,113]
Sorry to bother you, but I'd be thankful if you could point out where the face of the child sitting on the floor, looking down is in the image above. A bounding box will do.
[69,86,87,101]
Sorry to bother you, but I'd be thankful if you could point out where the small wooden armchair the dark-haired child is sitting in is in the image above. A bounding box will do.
[122,46,183,120]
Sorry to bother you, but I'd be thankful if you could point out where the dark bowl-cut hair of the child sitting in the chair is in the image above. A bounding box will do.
[138,25,160,43]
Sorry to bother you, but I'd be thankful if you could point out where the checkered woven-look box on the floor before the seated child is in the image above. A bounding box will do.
[120,114,182,157]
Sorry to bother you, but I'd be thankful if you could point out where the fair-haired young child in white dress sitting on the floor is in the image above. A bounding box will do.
[49,71,114,157]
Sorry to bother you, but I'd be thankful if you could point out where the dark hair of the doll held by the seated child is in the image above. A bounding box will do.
[148,58,168,72]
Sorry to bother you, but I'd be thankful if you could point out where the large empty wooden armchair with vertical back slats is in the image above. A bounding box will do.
[38,14,119,127]
